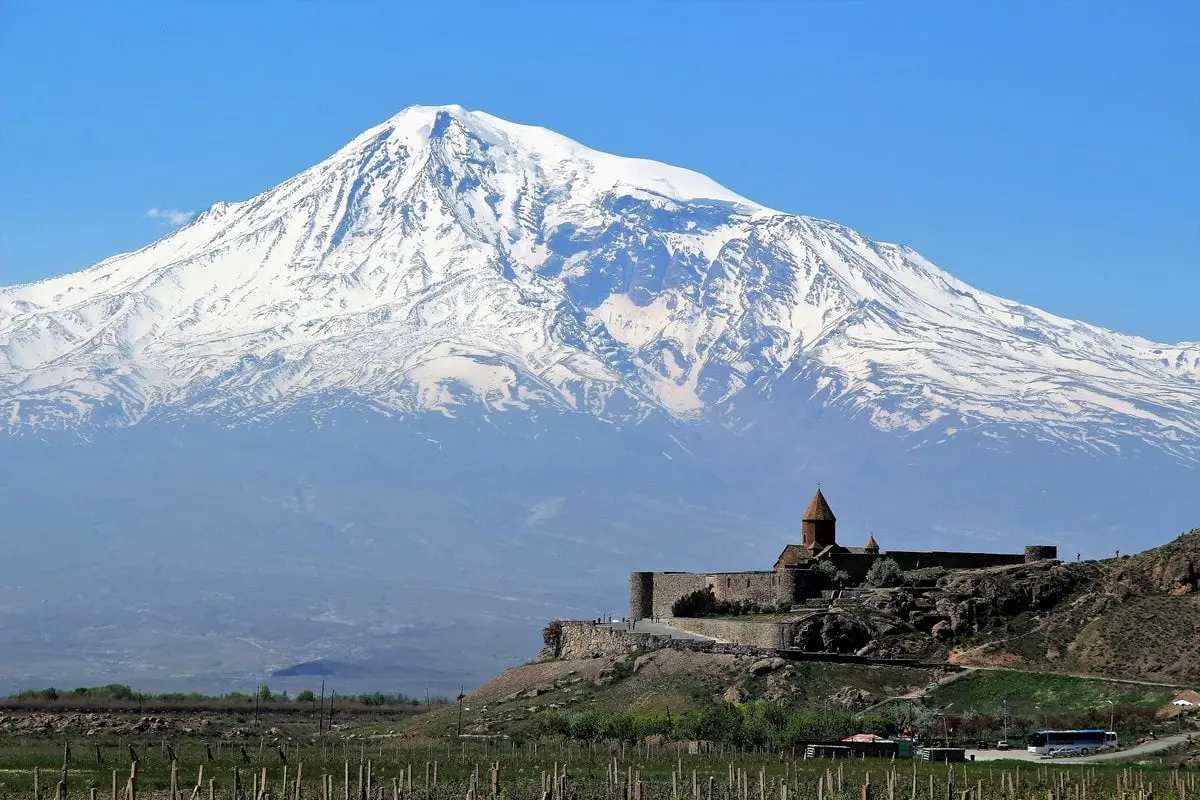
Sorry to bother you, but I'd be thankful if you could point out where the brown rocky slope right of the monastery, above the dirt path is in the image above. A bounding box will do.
[772,530,1200,682]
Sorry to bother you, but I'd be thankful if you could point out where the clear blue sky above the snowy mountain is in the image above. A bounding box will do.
[0,0,1200,342]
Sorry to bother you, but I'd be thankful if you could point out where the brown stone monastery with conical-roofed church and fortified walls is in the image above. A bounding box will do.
[629,486,1058,620]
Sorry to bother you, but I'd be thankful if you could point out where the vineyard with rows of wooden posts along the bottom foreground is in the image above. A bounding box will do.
[0,736,1200,800]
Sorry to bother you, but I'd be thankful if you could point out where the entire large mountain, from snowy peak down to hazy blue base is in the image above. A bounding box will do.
[0,107,1200,693]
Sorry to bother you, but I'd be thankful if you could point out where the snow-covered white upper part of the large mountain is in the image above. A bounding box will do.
[0,106,1200,459]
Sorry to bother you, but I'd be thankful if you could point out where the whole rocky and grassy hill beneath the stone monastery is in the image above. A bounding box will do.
[414,529,1200,734]
